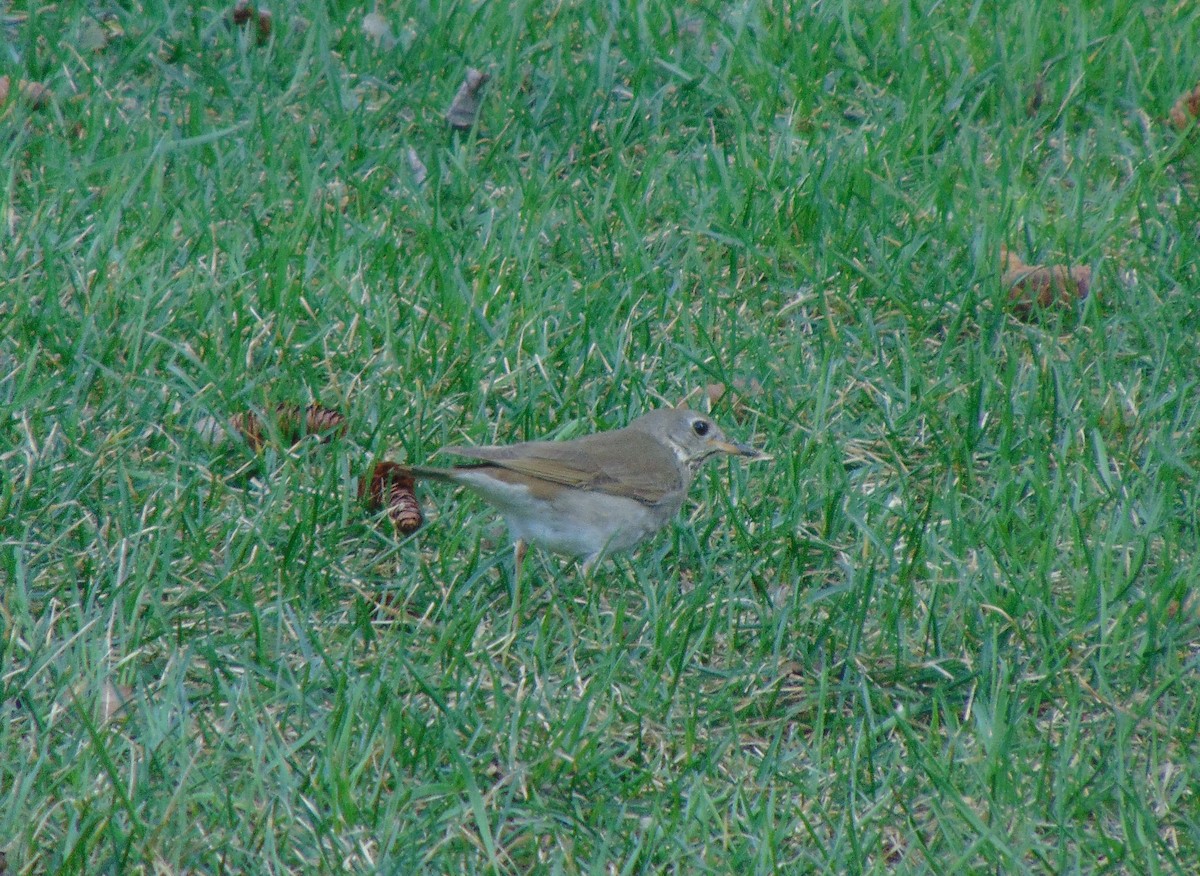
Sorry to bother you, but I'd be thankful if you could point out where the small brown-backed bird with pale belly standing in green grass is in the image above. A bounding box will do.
[404,407,770,578]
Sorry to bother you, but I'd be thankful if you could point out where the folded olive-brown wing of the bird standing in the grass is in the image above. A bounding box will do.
[445,430,685,505]
